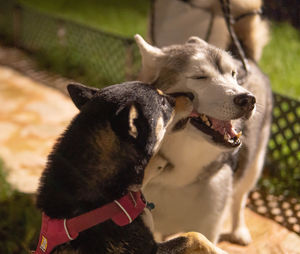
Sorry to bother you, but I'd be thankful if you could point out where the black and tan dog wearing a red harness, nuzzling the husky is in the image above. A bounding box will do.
[36,82,224,254]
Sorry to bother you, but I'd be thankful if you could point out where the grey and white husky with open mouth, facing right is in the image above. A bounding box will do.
[135,35,272,244]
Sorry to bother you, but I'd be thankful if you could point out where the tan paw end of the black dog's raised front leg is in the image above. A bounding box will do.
[180,232,227,254]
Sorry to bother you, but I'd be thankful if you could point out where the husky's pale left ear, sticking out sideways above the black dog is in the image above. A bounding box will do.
[134,34,164,83]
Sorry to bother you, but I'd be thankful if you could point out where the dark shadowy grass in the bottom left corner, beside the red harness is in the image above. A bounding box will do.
[0,161,41,254]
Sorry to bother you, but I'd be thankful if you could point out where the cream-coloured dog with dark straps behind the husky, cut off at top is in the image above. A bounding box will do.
[150,0,269,61]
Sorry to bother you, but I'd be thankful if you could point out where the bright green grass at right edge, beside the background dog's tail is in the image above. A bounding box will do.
[260,23,300,99]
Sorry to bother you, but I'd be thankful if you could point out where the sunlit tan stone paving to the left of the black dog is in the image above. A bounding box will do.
[0,66,77,192]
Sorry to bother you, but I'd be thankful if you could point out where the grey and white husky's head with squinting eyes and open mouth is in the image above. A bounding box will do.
[135,35,255,147]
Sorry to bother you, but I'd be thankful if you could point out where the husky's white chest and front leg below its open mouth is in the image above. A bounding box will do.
[145,125,232,241]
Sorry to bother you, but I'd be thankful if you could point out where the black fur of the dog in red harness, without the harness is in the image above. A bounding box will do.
[37,82,217,254]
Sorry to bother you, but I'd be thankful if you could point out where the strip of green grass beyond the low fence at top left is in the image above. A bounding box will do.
[19,0,150,37]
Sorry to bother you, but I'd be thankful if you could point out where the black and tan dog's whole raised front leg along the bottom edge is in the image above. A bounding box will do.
[157,232,227,254]
